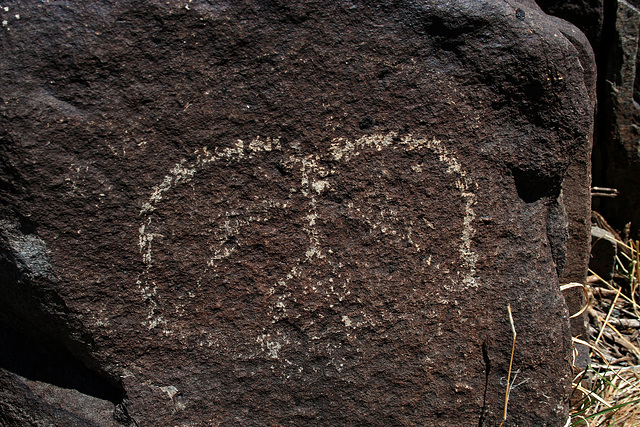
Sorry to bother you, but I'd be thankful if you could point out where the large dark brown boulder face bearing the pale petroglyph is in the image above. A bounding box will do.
[0,0,593,426]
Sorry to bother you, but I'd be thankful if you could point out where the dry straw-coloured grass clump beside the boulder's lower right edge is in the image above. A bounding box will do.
[570,213,640,427]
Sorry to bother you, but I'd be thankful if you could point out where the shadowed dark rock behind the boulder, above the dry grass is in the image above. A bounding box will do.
[538,0,640,239]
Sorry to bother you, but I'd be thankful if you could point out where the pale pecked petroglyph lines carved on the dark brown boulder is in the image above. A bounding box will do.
[137,132,478,348]
